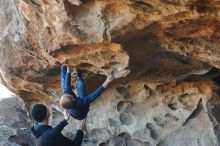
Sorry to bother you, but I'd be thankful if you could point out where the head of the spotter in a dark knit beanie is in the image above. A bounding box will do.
[31,104,50,123]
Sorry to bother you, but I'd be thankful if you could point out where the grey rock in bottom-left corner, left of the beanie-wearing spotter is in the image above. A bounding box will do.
[0,95,34,146]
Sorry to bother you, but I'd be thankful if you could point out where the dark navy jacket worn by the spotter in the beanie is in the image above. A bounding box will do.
[31,120,84,146]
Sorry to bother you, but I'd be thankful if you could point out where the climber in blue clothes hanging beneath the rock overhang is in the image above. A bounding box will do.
[60,65,113,120]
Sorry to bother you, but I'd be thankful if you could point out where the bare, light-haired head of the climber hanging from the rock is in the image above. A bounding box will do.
[60,94,75,109]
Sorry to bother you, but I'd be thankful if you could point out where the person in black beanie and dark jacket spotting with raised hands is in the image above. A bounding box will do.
[31,104,86,146]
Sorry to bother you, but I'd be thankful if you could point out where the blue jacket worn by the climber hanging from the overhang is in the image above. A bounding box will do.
[64,73,105,120]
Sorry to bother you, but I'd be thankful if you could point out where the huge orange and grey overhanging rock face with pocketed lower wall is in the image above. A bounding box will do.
[0,0,220,146]
